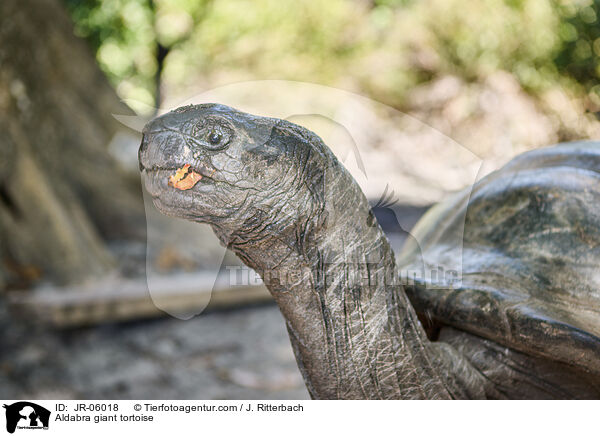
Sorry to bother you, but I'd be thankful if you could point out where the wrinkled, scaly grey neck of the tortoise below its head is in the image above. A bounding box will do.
[221,168,468,399]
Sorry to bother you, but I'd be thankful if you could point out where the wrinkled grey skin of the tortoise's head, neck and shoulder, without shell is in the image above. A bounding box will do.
[139,104,600,399]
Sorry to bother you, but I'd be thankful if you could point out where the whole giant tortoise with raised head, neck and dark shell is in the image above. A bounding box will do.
[139,104,600,399]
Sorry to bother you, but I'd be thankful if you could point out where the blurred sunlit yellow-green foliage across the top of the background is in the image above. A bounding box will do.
[65,0,600,114]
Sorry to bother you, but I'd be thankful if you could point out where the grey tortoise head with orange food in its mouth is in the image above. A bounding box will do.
[139,104,331,244]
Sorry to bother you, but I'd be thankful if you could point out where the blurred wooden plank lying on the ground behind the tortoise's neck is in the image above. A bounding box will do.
[8,273,272,327]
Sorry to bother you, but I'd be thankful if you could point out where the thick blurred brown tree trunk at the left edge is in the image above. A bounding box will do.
[0,0,145,287]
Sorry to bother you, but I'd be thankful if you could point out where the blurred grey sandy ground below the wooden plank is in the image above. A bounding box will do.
[0,304,308,399]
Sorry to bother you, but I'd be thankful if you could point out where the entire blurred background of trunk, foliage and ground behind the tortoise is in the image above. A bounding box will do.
[0,0,600,399]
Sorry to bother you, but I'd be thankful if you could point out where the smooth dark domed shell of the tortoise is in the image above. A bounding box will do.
[397,142,600,374]
